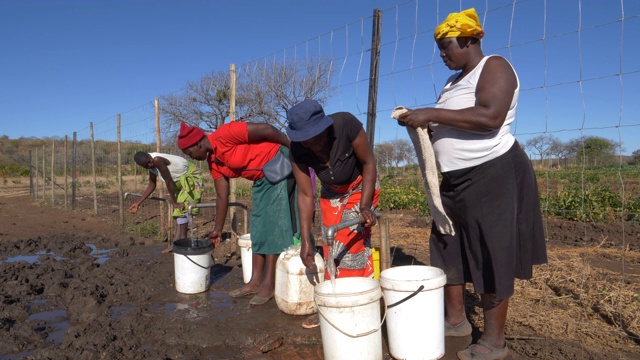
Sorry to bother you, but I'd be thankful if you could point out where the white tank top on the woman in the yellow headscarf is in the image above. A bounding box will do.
[429,56,520,172]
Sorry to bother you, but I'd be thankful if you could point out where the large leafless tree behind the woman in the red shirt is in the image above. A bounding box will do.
[160,58,334,137]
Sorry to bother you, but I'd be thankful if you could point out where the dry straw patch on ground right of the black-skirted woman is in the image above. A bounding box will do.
[508,248,640,350]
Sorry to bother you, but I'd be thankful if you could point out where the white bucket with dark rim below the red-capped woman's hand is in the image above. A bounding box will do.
[173,238,213,294]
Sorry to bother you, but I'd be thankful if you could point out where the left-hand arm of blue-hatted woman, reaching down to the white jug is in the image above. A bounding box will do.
[291,162,315,270]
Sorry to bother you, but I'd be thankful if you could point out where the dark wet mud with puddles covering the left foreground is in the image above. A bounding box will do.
[0,197,640,360]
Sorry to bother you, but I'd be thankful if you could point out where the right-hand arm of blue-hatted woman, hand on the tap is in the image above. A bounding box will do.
[351,129,378,226]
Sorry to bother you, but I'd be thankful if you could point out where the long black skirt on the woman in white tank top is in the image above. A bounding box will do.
[430,141,547,299]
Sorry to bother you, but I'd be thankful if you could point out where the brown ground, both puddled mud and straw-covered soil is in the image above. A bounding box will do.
[0,184,640,360]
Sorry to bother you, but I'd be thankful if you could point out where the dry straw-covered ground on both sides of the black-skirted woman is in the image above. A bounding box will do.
[380,213,640,352]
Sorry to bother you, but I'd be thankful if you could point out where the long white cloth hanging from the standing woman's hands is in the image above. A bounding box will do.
[391,106,456,235]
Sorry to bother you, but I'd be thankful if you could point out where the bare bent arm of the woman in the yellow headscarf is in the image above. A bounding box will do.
[399,56,518,132]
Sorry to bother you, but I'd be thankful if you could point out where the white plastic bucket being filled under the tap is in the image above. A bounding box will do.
[314,277,382,360]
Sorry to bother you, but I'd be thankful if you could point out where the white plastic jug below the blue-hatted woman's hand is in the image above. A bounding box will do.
[274,245,324,315]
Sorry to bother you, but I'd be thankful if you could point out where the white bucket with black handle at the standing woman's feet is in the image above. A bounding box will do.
[380,265,447,360]
